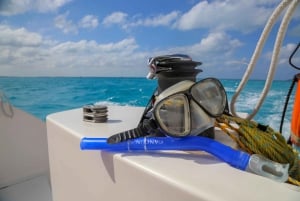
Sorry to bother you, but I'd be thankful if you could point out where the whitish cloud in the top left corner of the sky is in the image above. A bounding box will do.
[0,0,72,16]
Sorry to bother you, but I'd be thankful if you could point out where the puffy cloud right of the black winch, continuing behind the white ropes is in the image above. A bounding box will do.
[146,31,300,79]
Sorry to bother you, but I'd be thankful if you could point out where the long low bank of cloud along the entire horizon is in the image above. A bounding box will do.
[0,25,299,78]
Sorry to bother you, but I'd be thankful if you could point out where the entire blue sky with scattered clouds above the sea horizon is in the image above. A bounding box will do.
[0,0,300,79]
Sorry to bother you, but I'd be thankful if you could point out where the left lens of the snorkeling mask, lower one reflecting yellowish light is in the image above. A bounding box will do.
[154,94,190,137]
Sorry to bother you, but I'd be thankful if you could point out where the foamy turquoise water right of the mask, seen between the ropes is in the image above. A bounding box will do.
[223,80,294,138]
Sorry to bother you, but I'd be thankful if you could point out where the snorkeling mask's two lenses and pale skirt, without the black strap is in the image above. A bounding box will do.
[153,78,227,137]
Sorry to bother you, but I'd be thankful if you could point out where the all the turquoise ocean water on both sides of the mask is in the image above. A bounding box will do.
[0,77,294,137]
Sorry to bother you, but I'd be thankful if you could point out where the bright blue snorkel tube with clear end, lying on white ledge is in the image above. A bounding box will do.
[80,136,289,182]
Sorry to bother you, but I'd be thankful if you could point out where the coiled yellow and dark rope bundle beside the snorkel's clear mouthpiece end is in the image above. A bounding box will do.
[216,115,300,186]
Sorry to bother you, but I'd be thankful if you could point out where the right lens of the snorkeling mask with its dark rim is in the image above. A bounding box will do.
[191,78,226,116]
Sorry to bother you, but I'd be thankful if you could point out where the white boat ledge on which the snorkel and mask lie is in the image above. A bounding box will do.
[47,106,300,201]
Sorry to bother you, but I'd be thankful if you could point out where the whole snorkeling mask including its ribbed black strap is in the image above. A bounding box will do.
[107,78,227,144]
